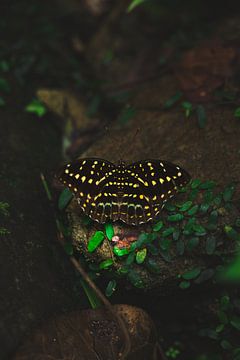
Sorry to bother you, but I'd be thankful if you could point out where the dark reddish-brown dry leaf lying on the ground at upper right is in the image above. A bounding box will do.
[175,41,236,102]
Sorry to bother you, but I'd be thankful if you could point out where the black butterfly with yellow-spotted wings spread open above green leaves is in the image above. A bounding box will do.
[58,158,190,225]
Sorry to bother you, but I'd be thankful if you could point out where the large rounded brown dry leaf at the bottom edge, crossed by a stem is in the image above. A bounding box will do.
[13,305,164,360]
